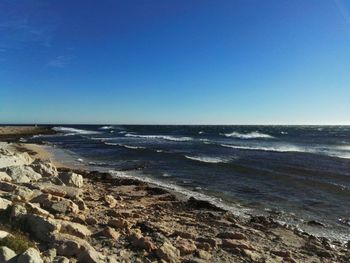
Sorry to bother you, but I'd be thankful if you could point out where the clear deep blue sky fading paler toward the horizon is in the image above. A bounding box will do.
[0,0,350,124]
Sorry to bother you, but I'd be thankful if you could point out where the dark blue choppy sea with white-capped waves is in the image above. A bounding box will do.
[30,125,350,242]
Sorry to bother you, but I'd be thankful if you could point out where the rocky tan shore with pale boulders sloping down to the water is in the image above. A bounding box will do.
[0,127,350,263]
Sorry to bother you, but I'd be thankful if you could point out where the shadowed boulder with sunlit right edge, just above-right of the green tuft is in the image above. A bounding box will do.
[24,214,61,242]
